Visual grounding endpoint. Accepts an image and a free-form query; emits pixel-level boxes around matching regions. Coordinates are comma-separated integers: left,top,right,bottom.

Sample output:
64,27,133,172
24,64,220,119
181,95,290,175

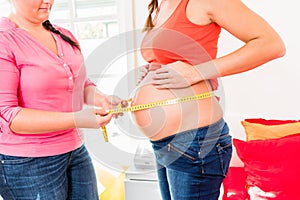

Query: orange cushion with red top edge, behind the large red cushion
241,119,300,141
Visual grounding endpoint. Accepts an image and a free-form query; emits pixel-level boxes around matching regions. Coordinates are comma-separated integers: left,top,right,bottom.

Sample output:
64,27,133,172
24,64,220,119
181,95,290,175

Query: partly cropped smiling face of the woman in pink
11,0,54,23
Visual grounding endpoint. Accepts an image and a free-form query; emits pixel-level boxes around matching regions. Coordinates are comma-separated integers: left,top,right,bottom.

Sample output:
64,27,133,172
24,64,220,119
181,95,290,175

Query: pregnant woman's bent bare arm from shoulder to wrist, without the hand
198,0,285,76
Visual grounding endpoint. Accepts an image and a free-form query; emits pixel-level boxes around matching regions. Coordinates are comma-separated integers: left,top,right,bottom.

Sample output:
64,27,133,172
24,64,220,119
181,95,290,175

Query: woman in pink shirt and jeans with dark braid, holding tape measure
0,0,121,200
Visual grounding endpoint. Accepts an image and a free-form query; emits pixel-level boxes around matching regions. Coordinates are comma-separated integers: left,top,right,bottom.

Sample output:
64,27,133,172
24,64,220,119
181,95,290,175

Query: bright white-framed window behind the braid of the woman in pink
50,0,119,56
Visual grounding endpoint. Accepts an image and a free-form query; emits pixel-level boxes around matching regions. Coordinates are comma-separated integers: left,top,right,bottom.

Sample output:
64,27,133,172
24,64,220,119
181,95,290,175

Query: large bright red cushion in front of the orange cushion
233,134,300,200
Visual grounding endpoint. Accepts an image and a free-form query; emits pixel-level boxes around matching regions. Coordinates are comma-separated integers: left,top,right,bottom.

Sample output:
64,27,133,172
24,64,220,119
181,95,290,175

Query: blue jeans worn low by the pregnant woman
151,119,232,200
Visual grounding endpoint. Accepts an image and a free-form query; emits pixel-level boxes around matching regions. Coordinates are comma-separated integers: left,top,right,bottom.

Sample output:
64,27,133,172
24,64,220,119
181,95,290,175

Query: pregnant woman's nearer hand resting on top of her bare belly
153,61,202,89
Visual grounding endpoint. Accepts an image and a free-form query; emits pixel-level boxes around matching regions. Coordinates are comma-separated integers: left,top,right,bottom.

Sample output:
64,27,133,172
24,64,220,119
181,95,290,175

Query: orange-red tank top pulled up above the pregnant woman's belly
141,0,221,89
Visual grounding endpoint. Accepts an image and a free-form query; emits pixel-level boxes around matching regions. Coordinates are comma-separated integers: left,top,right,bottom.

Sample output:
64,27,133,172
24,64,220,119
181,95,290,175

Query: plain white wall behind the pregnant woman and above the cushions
135,0,300,134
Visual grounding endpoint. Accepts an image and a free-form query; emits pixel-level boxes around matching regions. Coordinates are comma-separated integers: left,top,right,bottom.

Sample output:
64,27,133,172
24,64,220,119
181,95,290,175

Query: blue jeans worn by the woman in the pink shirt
0,146,98,200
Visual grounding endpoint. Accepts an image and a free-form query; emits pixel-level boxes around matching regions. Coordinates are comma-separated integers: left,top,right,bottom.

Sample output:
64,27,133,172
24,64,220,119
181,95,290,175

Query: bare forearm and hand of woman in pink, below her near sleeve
10,108,112,134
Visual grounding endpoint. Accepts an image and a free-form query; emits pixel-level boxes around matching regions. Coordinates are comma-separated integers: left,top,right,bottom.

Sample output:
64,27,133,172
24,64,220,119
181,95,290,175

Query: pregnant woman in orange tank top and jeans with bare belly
133,0,285,200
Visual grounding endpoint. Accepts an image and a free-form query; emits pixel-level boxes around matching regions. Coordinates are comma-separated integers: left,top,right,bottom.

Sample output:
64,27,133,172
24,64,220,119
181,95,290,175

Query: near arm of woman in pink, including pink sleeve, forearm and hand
0,69,112,134
